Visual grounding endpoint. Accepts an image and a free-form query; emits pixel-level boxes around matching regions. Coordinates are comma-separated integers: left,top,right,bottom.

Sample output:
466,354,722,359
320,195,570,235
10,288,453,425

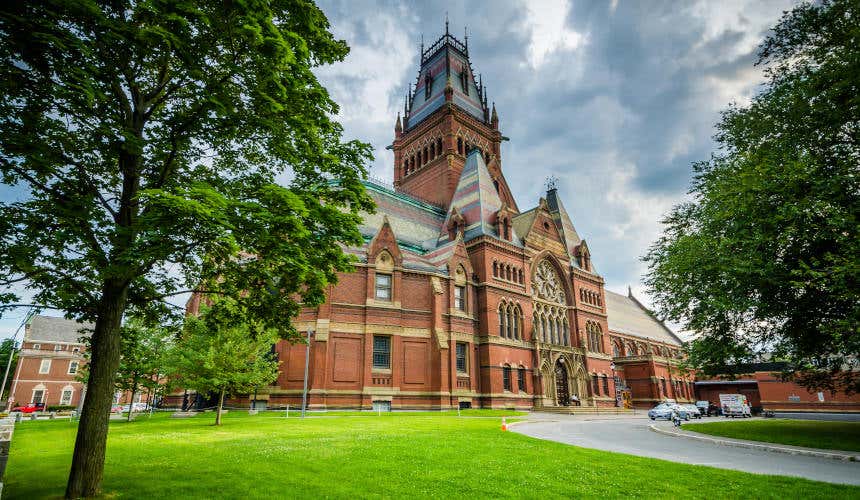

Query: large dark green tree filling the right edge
644,0,860,392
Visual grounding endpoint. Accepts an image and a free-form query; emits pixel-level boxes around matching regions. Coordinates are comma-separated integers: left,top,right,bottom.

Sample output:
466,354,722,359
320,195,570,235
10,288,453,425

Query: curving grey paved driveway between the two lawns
511,413,860,485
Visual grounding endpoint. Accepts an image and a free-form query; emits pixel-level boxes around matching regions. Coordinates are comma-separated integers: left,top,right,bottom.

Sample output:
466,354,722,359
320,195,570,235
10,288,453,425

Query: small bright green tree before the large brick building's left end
168,299,279,425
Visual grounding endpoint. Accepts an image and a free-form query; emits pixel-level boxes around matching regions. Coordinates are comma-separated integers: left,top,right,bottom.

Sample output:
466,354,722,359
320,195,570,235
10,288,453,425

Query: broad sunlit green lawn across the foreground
3,411,860,500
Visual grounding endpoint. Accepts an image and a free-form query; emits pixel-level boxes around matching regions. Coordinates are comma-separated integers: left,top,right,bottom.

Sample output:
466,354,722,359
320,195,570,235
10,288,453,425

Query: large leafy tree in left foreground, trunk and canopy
0,0,372,498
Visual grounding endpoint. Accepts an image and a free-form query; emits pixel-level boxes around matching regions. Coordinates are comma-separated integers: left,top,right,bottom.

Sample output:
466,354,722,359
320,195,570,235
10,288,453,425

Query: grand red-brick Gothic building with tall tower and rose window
189,30,693,408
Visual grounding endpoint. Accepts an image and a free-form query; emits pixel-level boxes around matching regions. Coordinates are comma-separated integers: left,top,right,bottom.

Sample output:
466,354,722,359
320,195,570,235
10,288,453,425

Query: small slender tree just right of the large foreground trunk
116,318,170,420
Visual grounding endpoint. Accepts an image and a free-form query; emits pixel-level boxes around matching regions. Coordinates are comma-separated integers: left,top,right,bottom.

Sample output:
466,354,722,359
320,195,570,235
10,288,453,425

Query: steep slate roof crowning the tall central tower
403,27,489,130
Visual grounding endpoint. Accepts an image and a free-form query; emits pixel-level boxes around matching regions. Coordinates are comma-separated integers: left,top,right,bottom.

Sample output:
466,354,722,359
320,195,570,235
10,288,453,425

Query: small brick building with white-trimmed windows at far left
7,315,92,407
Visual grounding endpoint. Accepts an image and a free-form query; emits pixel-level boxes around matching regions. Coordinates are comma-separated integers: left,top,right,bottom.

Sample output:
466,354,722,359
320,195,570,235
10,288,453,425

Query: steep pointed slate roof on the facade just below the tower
438,149,519,245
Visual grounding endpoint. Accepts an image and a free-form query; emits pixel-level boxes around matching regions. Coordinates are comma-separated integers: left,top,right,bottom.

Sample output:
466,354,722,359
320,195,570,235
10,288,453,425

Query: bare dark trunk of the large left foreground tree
66,282,128,498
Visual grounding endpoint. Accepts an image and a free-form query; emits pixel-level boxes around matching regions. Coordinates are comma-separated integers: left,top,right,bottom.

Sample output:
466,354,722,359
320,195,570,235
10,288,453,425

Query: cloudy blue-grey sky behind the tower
0,0,793,337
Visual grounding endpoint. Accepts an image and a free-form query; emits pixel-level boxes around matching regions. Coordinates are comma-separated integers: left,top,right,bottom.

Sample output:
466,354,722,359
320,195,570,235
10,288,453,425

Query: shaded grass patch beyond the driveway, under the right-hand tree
683,419,860,451
